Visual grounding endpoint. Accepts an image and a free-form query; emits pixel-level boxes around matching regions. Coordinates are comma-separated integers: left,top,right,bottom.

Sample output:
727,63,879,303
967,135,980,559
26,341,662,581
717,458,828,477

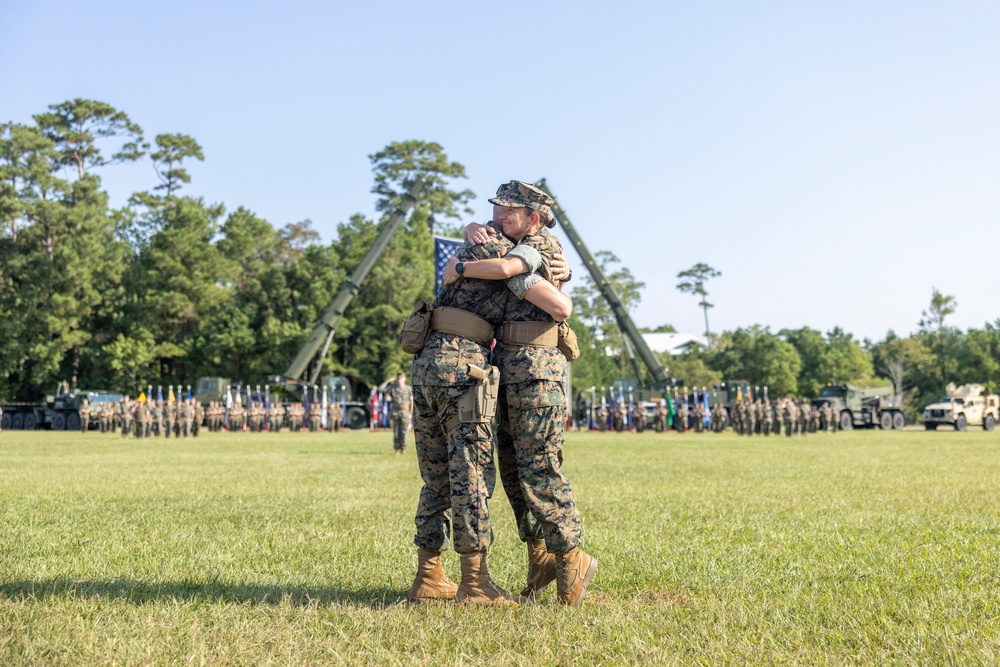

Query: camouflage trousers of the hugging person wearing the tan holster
412,385,496,553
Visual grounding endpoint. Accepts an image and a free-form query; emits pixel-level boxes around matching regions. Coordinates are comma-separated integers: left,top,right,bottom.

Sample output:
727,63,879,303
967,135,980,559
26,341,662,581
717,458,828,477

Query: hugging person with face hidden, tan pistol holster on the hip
412,206,572,604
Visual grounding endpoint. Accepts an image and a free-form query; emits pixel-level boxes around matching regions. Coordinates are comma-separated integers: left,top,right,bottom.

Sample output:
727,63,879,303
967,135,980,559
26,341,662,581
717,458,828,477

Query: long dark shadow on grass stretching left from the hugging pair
0,578,409,609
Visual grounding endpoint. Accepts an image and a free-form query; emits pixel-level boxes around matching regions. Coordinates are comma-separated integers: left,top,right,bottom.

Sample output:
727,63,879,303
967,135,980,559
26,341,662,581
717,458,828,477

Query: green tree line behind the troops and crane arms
0,99,1000,418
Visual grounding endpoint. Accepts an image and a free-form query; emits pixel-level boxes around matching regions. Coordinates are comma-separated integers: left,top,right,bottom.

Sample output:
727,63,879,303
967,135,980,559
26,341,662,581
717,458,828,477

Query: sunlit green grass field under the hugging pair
0,431,1000,665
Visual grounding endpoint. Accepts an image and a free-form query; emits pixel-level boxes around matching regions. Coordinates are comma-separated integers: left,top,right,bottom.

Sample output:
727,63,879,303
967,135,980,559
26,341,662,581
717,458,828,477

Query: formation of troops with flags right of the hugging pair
577,397,840,436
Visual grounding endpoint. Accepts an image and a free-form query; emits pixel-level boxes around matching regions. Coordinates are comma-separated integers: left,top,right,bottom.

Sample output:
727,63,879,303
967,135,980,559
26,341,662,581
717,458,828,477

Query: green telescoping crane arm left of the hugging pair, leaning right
283,178,427,386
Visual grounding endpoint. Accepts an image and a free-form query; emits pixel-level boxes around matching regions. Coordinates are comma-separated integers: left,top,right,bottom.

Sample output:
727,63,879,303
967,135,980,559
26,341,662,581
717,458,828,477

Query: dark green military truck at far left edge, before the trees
0,383,122,431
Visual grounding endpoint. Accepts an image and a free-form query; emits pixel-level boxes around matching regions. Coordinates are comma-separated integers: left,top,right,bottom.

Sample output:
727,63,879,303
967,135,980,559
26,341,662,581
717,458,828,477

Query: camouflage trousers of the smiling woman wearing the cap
497,380,583,553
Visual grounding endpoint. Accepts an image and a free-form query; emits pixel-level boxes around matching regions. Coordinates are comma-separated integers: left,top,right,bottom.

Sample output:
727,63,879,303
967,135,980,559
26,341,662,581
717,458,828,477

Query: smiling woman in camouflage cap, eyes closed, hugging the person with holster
445,181,597,606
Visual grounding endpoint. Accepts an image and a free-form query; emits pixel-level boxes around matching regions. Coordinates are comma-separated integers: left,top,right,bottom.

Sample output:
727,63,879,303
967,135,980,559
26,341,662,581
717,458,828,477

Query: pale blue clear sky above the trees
0,0,1000,340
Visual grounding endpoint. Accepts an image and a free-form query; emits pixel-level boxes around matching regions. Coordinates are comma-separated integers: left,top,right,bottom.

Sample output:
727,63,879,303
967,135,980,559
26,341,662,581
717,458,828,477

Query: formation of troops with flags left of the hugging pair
79,396,344,438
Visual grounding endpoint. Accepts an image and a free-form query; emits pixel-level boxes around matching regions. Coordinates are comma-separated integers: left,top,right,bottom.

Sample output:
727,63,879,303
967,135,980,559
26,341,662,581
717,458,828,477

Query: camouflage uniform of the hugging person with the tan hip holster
410,235,532,553
